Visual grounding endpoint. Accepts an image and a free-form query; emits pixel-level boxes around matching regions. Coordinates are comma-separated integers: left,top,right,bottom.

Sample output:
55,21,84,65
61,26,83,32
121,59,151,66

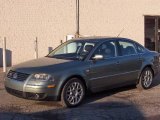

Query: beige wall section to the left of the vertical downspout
0,0,75,64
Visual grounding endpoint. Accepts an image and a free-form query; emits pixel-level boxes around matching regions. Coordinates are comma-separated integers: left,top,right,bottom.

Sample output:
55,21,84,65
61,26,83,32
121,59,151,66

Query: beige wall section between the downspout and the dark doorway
80,0,160,44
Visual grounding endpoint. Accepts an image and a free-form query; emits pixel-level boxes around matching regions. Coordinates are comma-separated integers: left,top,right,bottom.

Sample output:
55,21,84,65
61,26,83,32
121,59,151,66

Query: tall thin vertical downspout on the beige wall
75,0,79,38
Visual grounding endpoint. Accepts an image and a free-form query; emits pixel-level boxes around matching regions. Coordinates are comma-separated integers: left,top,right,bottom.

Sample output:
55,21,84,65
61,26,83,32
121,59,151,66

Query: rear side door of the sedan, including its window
117,40,142,84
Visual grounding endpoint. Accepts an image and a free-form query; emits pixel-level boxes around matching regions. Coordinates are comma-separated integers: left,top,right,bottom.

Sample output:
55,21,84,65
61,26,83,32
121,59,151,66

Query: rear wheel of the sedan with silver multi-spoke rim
137,67,153,90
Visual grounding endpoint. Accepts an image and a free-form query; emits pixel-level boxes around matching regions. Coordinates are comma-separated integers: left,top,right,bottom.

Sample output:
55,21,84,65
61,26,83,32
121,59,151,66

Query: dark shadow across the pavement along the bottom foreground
0,101,145,120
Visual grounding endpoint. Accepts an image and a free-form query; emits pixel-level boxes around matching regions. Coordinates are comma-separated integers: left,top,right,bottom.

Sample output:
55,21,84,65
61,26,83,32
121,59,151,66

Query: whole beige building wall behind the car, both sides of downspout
0,0,160,64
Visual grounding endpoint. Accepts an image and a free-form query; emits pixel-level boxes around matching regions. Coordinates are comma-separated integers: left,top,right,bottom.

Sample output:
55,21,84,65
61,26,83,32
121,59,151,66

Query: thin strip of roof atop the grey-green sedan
72,36,130,42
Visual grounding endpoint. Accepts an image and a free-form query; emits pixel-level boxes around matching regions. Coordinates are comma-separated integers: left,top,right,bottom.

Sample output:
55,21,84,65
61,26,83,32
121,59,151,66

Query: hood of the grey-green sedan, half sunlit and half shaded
11,57,78,74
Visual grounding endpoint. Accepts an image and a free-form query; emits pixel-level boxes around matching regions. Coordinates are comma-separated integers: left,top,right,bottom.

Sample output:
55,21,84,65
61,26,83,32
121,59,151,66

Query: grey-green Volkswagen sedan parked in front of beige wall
5,37,159,107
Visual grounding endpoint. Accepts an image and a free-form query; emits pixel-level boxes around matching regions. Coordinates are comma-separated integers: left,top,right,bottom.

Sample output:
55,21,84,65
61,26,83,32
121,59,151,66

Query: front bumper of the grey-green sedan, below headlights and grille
5,77,58,100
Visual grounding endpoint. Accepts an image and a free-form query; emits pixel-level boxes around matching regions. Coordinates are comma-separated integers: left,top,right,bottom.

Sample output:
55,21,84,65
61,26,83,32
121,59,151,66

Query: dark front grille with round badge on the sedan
7,70,29,81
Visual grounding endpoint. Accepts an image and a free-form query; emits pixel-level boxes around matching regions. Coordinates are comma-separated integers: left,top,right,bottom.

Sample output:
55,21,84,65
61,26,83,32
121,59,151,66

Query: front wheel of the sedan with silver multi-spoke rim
61,78,85,107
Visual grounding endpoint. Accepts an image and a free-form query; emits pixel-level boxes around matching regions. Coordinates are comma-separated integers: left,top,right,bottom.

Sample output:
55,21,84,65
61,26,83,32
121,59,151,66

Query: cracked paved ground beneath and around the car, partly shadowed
0,72,160,120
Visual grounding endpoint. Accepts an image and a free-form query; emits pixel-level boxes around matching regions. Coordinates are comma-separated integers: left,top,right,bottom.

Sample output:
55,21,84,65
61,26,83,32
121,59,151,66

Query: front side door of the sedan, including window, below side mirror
89,41,118,91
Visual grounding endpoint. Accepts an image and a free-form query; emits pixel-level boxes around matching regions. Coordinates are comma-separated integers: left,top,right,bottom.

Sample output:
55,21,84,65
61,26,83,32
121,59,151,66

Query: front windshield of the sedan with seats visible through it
46,41,96,60
